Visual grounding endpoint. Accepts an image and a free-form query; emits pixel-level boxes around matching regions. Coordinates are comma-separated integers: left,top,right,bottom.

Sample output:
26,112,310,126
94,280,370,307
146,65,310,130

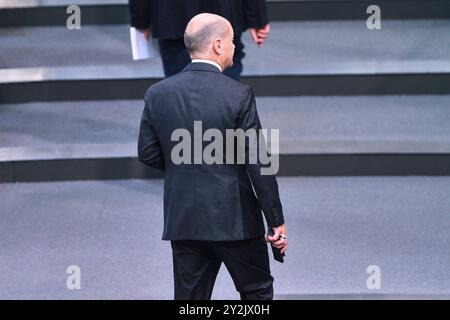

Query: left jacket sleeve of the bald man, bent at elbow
138,96,165,171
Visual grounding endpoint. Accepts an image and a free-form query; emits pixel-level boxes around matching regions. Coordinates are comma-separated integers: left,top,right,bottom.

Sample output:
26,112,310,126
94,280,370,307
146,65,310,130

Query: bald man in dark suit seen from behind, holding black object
138,13,288,299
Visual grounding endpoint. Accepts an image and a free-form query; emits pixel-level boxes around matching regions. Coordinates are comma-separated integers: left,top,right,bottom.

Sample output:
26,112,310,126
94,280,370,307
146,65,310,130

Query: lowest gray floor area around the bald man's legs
0,177,450,299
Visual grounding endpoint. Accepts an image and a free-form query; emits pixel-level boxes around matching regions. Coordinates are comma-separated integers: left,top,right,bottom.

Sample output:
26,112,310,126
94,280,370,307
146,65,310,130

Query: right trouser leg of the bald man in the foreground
214,236,273,300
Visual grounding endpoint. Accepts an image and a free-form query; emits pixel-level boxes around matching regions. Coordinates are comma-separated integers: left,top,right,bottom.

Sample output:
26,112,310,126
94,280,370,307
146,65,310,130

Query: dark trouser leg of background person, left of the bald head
158,38,191,77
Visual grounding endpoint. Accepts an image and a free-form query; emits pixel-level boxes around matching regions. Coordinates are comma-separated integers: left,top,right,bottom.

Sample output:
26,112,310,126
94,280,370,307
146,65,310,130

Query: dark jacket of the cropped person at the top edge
129,0,268,39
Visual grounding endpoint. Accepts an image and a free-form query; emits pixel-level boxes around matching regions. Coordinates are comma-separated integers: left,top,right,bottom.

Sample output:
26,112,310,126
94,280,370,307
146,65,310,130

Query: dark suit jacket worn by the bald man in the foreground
138,63,284,241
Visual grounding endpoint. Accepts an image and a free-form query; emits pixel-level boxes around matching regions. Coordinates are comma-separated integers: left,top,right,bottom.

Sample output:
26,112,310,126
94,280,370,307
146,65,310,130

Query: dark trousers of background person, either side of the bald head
158,35,245,81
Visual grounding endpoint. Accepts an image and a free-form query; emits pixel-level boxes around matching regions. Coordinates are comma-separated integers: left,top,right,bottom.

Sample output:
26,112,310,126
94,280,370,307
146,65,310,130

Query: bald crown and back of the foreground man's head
184,13,233,56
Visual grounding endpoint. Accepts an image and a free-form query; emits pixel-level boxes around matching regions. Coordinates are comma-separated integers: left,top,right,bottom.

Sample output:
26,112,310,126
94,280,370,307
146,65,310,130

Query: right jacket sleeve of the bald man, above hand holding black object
237,86,284,227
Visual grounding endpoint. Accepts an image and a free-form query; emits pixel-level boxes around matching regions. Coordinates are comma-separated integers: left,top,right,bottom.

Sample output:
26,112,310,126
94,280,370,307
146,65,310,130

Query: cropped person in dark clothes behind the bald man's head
129,0,270,80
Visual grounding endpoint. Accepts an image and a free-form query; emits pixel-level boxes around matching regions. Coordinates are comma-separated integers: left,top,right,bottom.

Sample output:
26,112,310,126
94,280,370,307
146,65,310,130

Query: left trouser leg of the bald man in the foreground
171,241,222,300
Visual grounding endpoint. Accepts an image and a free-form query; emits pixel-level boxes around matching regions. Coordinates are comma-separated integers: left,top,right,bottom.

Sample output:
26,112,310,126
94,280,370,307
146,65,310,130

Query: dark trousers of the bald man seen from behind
171,237,273,300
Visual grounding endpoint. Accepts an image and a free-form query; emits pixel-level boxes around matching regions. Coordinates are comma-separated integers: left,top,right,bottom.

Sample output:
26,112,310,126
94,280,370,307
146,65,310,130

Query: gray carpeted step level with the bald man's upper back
0,95,450,151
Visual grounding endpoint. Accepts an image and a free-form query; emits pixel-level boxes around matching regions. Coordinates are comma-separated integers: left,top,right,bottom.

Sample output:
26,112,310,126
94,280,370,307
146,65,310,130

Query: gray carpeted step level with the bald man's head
0,19,450,73
